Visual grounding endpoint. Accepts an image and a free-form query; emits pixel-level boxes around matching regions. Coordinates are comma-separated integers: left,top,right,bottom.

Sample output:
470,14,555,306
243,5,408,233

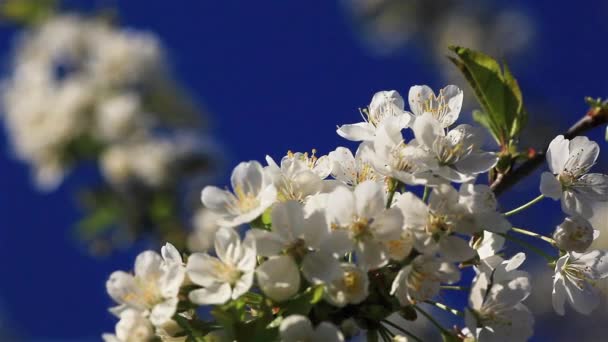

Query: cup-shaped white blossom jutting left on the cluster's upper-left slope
201,161,277,227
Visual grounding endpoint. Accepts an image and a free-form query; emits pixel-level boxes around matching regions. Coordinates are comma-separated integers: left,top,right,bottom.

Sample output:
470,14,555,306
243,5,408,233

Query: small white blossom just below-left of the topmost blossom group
328,147,380,186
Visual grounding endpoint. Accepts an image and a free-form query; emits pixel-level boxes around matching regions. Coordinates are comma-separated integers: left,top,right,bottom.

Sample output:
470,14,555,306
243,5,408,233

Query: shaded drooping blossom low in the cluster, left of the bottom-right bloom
391,255,460,306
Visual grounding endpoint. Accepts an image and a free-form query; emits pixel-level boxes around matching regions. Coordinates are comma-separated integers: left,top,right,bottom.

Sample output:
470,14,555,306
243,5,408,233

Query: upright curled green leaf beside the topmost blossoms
449,46,527,147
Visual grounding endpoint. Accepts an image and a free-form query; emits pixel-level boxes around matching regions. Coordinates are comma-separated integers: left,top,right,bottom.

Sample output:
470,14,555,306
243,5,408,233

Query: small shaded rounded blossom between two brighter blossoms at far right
553,216,599,253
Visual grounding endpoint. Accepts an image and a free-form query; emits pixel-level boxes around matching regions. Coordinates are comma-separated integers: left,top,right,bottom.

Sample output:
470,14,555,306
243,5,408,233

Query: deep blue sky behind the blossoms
0,0,608,341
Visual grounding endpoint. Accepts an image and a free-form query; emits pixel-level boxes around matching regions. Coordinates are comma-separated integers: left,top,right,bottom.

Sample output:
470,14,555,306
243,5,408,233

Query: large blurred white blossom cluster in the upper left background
1,15,204,189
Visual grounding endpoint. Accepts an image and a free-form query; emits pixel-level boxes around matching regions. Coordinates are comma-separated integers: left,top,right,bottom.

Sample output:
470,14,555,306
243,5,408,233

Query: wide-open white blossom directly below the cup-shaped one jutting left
186,228,256,305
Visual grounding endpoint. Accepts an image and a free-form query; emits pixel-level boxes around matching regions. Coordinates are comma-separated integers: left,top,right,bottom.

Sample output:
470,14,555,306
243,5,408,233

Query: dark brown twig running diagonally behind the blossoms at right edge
492,108,608,196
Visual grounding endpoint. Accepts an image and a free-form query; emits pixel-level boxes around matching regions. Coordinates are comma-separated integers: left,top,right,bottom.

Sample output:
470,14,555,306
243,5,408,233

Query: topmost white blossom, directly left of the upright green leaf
408,85,464,128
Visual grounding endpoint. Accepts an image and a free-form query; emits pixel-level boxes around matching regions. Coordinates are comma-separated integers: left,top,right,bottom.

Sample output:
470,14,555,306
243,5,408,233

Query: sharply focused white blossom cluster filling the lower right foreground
105,85,608,341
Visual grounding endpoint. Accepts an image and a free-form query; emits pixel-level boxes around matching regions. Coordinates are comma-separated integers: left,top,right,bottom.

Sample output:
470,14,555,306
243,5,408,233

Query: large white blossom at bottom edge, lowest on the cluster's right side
465,253,534,342
